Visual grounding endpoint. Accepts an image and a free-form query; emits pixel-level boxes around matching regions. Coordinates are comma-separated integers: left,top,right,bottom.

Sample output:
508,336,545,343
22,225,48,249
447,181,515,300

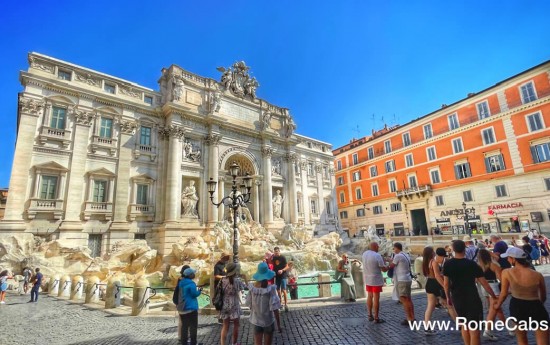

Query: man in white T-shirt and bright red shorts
363,242,388,323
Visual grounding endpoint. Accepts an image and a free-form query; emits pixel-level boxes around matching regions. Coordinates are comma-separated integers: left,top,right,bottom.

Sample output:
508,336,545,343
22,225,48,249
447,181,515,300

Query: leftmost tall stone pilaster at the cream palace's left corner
0,96,44,224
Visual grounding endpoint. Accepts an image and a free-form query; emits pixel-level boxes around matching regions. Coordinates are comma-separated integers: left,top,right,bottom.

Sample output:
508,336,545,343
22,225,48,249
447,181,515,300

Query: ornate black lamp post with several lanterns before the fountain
206,162,252,263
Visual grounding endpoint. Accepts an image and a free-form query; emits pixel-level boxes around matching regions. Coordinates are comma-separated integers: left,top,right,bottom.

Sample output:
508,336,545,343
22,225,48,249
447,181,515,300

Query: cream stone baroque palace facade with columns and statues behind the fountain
0,53,337,255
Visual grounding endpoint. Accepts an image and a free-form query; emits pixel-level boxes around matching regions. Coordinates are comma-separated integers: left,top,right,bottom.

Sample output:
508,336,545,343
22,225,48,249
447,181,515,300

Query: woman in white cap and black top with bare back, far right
494,247,550,345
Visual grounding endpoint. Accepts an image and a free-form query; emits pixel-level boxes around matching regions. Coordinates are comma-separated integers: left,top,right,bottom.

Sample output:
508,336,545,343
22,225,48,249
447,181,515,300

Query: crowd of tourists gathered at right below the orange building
362,232,550,345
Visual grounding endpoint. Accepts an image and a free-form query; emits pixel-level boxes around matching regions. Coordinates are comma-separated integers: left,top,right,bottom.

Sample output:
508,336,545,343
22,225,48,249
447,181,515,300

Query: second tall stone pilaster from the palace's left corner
59,109,96,245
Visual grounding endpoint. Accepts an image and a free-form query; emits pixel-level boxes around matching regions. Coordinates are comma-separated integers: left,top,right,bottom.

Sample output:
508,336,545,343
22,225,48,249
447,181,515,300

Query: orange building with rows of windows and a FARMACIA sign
333,61,550,235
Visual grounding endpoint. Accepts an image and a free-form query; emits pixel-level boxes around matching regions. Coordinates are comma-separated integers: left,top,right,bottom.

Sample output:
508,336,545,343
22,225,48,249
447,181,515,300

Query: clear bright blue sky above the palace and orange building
0,0,550,187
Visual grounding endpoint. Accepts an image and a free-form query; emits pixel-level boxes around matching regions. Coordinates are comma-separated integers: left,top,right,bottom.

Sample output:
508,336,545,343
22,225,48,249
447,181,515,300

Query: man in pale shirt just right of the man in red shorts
389,242,414,326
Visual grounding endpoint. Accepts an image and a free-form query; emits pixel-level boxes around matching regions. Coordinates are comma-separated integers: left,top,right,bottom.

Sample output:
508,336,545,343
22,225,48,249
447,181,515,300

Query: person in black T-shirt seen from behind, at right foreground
443,240,496,345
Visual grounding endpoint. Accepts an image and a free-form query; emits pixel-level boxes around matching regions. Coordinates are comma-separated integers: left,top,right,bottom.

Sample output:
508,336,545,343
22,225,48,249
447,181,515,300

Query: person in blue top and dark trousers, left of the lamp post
177,268,202,345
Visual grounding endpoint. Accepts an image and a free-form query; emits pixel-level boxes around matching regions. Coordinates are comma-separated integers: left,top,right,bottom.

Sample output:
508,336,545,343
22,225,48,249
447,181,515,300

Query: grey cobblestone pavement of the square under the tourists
0,265,550,345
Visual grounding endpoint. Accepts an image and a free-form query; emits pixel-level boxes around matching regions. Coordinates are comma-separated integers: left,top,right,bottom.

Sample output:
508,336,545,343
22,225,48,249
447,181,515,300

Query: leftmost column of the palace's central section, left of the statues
164,125,183,222
